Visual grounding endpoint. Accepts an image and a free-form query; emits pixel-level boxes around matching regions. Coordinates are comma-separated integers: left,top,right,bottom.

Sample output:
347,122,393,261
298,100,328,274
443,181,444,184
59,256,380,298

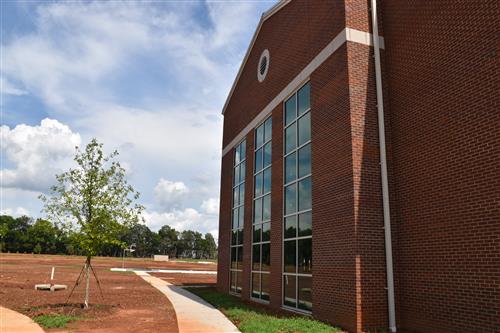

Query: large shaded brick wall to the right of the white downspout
381,0,500,333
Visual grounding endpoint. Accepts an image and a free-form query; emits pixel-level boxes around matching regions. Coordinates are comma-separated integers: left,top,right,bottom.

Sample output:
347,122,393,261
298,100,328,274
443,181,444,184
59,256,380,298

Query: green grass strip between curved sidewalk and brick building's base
186,288,342,333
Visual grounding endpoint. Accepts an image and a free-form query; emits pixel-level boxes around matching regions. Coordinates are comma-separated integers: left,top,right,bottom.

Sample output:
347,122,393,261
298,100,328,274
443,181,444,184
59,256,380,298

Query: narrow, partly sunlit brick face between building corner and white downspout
347,42,387,331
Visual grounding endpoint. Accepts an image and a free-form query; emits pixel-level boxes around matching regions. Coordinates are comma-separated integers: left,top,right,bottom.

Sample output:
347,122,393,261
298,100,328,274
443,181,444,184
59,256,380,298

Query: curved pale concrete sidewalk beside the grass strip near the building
135,272,240,333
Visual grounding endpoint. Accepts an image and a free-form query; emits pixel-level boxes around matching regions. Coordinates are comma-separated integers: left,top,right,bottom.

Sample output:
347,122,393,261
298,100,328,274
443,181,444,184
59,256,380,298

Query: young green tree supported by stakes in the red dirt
40,139,144,307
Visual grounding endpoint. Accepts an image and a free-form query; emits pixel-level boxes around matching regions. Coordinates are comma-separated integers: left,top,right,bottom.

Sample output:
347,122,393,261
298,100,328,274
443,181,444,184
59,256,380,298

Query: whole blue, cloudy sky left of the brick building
0,0,275,238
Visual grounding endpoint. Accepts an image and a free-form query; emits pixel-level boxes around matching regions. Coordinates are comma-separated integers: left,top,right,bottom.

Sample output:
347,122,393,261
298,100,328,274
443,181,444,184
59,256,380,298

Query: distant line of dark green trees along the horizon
0,215,217,259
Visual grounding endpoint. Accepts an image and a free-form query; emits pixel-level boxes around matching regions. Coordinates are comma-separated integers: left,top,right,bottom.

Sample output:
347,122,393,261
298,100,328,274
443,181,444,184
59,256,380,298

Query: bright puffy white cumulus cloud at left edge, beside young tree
0,119,81,192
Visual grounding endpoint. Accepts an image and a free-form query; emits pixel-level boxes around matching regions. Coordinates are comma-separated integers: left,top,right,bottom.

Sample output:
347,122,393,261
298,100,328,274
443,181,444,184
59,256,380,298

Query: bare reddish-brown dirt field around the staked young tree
0,254,217,333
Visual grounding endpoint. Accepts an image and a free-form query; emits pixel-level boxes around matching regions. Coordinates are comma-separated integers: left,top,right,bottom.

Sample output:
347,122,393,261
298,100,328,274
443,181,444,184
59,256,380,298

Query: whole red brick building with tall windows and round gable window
218,0,500,332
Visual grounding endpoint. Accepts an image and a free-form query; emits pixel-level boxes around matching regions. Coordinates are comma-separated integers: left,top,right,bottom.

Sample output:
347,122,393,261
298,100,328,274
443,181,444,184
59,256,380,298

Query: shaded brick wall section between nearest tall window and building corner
311,45,356,330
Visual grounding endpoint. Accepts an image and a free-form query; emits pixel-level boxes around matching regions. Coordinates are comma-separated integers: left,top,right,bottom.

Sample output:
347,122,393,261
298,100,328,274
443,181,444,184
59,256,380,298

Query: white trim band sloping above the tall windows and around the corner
222,28,384,156
